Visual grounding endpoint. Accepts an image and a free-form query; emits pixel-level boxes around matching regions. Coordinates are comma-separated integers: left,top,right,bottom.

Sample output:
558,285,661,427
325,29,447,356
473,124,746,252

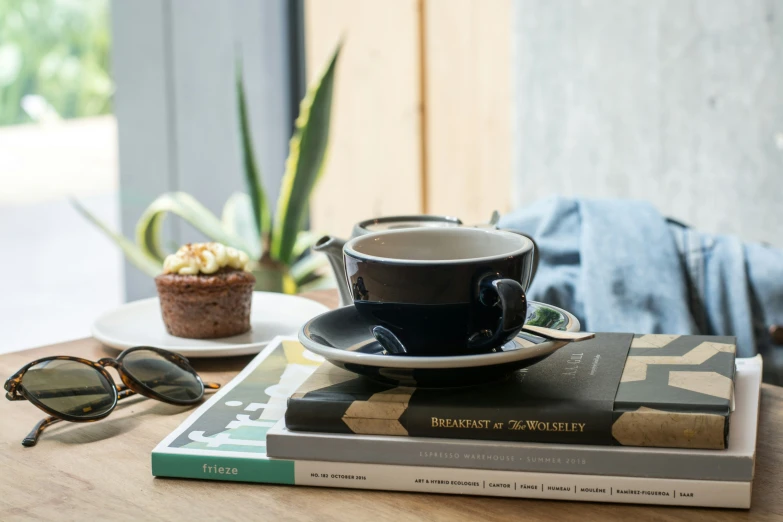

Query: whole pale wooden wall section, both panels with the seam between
305,0,511,236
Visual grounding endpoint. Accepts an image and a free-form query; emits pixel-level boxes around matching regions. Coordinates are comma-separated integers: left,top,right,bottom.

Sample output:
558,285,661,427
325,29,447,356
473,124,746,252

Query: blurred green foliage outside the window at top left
0,0,114,125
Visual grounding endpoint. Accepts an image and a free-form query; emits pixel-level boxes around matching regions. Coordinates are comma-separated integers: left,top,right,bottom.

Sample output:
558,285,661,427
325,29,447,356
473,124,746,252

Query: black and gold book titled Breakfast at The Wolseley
285,333,736,449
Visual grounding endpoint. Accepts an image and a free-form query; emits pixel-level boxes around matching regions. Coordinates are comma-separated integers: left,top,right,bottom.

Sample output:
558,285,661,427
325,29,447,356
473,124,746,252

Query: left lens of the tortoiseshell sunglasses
22,359,117,419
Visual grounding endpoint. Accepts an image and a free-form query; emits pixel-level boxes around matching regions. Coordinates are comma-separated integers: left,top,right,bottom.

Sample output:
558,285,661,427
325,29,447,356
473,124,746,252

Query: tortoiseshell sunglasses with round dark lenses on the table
5,346,220,446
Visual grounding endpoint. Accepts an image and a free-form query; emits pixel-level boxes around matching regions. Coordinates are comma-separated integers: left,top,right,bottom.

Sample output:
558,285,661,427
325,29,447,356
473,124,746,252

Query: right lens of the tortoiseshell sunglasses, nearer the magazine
122,350,204,401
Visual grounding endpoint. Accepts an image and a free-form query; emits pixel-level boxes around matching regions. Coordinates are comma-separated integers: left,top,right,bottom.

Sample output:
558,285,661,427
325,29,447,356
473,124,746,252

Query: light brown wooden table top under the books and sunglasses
0,291,783,522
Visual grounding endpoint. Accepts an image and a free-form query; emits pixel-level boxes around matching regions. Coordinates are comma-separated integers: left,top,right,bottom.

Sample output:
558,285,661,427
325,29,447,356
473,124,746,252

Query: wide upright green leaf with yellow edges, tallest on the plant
270,44,342,264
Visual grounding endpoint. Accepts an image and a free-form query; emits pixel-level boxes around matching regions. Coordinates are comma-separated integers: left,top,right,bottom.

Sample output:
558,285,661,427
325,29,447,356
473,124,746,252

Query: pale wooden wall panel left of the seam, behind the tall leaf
305,0,422,236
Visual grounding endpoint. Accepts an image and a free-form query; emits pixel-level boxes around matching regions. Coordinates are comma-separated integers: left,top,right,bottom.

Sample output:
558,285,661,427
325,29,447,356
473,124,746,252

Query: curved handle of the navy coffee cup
471,274,527,350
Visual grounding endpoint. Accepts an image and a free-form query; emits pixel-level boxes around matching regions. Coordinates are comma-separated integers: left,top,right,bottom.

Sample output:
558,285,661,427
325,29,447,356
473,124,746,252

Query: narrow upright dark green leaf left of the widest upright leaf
236,60,272,247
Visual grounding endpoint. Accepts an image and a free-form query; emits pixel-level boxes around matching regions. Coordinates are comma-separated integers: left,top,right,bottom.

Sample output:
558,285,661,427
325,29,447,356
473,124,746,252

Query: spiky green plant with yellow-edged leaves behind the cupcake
72,45,340,293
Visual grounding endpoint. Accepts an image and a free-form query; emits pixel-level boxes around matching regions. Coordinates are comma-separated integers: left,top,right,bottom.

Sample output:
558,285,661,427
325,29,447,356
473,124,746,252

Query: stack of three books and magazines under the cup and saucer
152,334,761,508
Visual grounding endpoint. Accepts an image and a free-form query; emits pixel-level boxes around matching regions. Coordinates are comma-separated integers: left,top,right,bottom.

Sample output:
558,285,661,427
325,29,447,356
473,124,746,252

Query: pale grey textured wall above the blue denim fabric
513,0,783,246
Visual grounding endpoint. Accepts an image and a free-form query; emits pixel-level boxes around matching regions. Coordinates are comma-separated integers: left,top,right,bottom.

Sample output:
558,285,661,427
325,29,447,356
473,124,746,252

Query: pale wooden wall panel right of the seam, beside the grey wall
424,0,512,223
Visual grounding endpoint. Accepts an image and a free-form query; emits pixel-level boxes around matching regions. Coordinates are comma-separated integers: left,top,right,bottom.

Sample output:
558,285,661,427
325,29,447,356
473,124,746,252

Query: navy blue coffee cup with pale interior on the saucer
343,227,534,356
